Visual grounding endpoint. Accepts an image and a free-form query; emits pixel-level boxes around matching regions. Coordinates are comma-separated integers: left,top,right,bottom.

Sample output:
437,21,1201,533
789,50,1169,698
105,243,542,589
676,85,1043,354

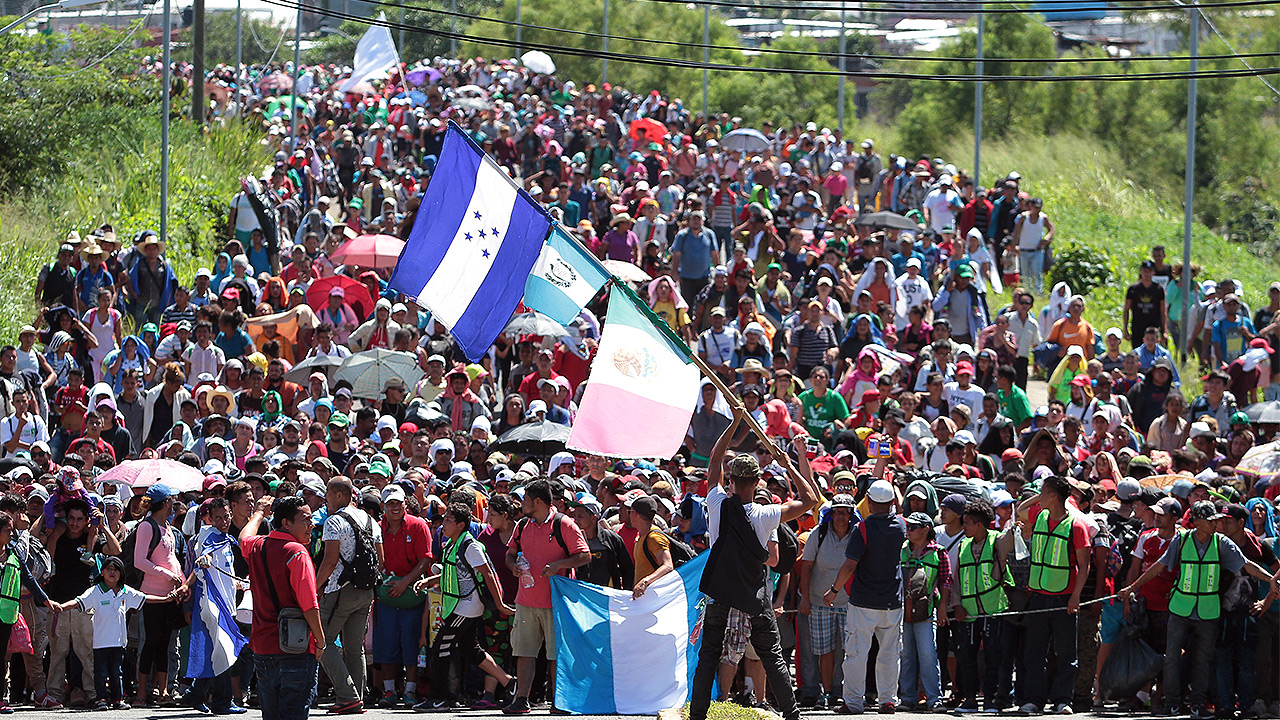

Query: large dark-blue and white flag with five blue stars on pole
390,122,552,361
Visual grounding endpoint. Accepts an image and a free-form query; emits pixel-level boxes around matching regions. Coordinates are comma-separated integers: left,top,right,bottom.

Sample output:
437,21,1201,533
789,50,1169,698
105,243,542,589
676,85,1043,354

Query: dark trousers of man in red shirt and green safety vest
1019,592,1080,707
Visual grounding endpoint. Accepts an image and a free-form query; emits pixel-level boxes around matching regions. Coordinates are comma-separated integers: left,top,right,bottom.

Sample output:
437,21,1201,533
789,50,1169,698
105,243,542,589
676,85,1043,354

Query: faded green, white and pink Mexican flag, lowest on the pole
568,284,700,457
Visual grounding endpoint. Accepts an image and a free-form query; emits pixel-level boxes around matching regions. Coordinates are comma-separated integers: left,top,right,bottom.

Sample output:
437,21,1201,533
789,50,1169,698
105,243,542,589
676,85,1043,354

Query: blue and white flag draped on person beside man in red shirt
187,525,248,678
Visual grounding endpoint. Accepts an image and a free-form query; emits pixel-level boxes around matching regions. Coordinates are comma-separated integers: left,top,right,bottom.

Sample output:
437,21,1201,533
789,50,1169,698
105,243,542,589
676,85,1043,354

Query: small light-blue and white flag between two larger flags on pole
525,223,609,325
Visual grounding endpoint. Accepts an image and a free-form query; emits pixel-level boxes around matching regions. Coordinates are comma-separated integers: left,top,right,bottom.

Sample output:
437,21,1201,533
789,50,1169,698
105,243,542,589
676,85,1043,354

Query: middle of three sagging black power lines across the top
353,0,1280,64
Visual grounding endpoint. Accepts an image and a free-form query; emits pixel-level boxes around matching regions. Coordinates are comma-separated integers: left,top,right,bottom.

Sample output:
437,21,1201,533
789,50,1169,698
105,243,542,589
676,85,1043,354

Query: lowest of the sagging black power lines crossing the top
277,0,1280,82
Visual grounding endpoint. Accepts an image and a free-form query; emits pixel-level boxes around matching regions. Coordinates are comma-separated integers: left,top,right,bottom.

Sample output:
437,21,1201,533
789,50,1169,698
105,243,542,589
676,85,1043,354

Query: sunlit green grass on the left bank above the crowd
0,118,271,342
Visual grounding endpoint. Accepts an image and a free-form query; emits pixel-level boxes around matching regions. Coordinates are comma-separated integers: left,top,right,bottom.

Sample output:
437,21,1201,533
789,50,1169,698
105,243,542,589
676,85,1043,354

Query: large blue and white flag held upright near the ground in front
552,552,708,715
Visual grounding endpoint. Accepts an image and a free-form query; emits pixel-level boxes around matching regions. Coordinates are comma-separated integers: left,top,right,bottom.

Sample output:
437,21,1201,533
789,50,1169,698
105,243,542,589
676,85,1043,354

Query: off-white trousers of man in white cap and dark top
844,605,902,710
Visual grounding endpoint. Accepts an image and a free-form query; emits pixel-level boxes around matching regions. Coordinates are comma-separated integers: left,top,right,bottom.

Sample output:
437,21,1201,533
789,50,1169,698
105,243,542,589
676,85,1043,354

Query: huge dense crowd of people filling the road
0,53,1280,720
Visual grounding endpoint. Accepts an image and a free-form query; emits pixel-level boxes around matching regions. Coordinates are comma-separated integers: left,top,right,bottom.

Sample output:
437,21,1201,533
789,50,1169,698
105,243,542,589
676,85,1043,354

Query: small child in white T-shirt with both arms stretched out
49,555,178,710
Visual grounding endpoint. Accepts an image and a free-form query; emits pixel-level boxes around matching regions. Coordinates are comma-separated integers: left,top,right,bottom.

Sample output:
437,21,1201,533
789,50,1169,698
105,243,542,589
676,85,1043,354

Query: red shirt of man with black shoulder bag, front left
241,530,319,655
